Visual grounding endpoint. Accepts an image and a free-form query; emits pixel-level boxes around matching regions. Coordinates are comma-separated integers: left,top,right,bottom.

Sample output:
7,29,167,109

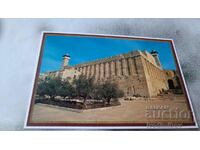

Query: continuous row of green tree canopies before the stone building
37,75,124,105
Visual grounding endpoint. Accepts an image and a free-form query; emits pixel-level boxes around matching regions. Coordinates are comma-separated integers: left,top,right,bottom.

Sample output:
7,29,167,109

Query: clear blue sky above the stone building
40,35,175,73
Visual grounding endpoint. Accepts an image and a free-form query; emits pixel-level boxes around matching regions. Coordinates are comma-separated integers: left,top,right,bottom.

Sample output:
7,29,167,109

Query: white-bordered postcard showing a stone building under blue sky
25,32,197,129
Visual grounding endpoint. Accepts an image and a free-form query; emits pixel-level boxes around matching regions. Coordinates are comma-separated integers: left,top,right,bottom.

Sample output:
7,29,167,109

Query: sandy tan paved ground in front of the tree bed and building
31,95,192,123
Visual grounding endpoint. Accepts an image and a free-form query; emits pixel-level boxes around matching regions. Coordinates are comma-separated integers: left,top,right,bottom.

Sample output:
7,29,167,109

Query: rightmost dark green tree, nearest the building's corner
96,81,124,104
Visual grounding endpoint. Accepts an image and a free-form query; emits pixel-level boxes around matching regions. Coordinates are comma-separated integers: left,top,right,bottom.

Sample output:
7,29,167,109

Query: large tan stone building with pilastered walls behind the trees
42,50,177,97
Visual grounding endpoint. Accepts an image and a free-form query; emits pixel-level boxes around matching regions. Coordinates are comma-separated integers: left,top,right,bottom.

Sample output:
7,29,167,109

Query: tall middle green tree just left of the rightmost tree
73,75,94,106
